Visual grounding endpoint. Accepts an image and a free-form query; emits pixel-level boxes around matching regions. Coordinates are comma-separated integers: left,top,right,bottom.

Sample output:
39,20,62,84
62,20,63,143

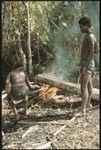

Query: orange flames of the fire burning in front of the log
39,84,58,101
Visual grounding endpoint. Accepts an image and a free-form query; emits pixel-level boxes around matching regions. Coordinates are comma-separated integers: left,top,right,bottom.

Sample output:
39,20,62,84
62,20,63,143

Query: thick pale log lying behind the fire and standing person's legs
36,74,99,101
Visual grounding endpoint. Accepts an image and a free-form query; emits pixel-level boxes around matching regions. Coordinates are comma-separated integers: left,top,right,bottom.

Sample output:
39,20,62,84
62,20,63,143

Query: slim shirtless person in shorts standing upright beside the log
75,16,96,116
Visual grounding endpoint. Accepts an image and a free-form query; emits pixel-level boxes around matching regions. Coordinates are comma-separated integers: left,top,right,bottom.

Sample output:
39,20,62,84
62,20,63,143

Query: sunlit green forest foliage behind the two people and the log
2,1,99,89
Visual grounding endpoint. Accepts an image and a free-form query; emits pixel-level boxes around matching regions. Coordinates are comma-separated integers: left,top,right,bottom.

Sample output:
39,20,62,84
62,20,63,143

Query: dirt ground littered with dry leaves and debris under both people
2,89,100,149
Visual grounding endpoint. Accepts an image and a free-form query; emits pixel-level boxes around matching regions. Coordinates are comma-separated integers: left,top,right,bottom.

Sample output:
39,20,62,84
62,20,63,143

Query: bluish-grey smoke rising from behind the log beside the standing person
44,1,99,82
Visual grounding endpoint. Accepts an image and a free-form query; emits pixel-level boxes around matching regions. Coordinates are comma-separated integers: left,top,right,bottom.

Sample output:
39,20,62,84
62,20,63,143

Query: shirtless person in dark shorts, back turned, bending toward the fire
5,63,35,117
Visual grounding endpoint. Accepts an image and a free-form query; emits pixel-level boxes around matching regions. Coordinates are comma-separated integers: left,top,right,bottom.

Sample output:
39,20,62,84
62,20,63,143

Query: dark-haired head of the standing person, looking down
78,16,91,33
